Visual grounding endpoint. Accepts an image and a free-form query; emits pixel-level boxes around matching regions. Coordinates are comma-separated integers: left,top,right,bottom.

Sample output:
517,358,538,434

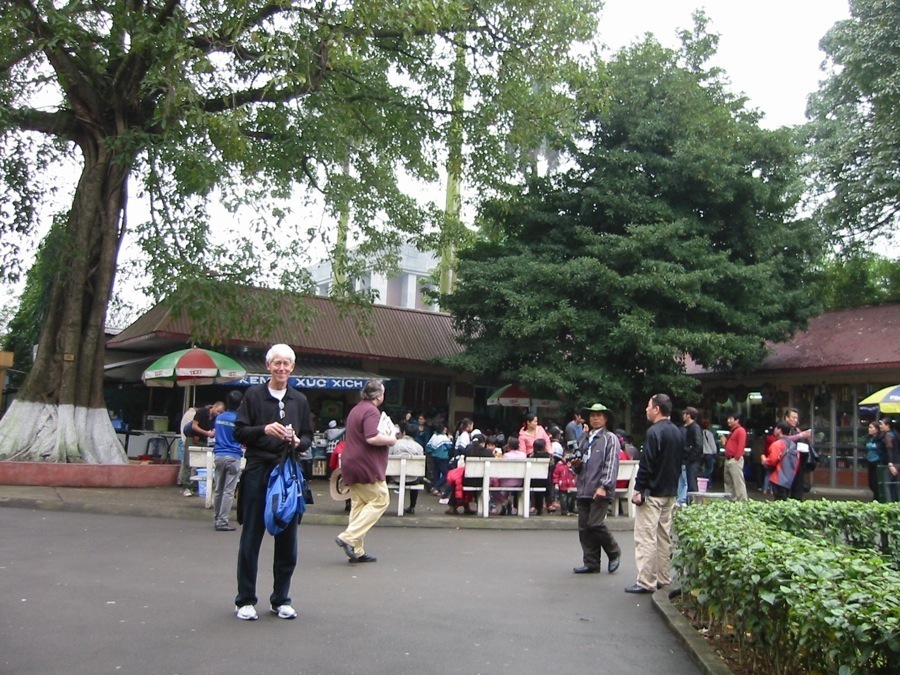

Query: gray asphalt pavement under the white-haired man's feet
0,510,701,674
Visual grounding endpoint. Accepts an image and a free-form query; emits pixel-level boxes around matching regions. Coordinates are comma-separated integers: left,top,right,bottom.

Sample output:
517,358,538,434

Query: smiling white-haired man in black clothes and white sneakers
234,344,313,621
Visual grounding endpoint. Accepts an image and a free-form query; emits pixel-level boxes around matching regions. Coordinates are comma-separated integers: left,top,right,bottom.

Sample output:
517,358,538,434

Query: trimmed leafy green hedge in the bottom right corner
674,501,900,673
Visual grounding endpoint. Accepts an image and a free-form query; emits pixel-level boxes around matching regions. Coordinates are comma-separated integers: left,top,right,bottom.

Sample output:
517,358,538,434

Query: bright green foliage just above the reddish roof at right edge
821,247,900,310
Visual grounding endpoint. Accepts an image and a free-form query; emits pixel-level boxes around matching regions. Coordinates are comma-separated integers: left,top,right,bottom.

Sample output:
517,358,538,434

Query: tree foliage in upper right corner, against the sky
807,0,900,246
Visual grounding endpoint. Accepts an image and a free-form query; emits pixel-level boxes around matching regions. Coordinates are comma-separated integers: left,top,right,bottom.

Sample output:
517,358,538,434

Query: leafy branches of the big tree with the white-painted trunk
0,0,600,336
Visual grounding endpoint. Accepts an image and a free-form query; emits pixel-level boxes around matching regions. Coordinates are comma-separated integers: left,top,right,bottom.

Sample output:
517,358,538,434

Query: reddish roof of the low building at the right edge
688,304,900,375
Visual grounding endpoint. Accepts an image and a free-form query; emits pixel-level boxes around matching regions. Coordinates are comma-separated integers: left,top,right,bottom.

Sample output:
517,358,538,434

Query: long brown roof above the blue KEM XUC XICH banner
107,289,462,362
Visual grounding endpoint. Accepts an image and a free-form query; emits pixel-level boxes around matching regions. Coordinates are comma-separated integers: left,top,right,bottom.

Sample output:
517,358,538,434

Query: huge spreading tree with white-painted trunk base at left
0,0,598,462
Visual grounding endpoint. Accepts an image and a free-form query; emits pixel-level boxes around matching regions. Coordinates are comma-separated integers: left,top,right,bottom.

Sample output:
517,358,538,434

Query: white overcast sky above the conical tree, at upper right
600,0,850,128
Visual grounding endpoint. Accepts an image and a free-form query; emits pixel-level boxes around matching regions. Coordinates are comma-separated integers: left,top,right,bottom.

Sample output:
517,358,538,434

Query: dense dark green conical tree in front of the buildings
441,23,821,403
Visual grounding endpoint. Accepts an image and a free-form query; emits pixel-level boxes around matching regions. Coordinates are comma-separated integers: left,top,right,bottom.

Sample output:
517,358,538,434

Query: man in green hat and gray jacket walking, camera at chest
571,403,622,574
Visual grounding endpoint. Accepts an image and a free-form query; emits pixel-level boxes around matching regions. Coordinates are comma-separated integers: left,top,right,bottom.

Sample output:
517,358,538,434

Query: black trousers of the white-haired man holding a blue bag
234,465,299,607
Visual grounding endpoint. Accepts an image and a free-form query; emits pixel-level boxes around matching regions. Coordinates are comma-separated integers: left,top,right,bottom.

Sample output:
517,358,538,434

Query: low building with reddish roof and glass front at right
688,304,900,488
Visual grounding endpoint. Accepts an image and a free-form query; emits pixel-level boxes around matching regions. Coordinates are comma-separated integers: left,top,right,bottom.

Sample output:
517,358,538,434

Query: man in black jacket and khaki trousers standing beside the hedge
625,394,684,593
